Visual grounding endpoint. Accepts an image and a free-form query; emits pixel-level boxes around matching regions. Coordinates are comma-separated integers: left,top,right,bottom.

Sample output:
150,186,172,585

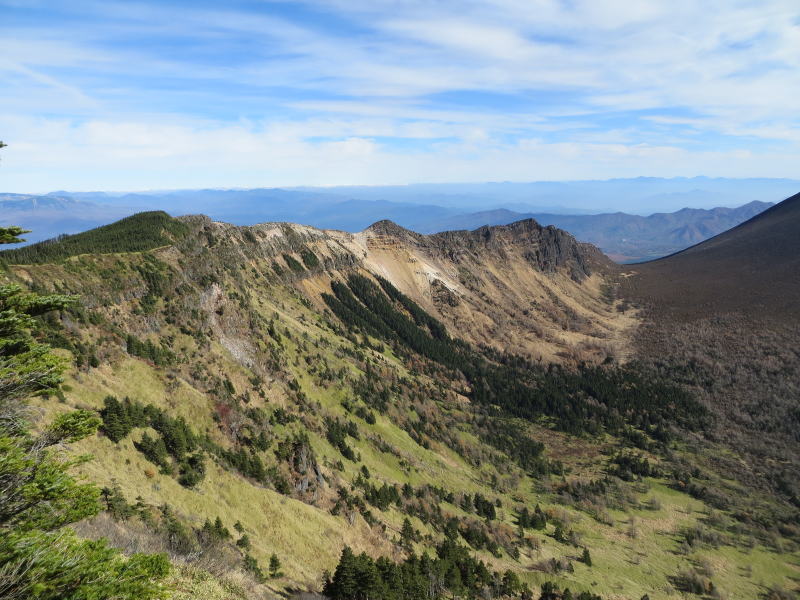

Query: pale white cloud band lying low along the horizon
0,120,800,192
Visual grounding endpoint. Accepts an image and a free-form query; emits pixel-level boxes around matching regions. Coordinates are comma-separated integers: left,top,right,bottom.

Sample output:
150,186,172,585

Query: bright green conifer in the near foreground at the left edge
0,227,170,600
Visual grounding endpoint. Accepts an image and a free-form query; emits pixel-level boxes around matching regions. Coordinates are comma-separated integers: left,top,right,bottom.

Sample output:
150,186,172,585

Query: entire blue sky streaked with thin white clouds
0,0,800,192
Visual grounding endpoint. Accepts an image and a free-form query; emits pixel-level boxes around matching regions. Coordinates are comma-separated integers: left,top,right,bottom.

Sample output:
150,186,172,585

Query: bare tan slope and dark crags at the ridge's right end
332,219,635,361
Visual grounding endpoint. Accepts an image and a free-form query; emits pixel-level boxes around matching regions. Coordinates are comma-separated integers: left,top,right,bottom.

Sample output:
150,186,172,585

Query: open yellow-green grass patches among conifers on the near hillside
20,243,798,599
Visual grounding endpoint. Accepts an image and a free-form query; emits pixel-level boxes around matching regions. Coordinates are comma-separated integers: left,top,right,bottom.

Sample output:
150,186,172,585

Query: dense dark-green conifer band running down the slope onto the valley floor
323,275,710,442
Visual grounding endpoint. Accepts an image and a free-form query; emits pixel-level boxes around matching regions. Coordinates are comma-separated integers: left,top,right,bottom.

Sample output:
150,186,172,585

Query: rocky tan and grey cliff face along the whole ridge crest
162,217,635,361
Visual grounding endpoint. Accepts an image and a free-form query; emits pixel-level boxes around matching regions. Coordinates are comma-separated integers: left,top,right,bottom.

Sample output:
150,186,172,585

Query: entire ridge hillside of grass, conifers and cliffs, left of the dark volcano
0,213,800,600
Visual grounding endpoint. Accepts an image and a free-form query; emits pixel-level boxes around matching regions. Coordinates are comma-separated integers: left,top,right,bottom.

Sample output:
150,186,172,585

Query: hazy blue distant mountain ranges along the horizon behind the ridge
0,177,788,262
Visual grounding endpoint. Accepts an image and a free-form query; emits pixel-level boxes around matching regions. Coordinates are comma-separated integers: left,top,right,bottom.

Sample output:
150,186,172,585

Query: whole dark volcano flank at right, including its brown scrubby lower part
619,194,800,520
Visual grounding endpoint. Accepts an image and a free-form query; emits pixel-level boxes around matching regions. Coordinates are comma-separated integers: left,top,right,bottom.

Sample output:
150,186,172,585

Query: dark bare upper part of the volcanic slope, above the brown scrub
622,194,800,320
